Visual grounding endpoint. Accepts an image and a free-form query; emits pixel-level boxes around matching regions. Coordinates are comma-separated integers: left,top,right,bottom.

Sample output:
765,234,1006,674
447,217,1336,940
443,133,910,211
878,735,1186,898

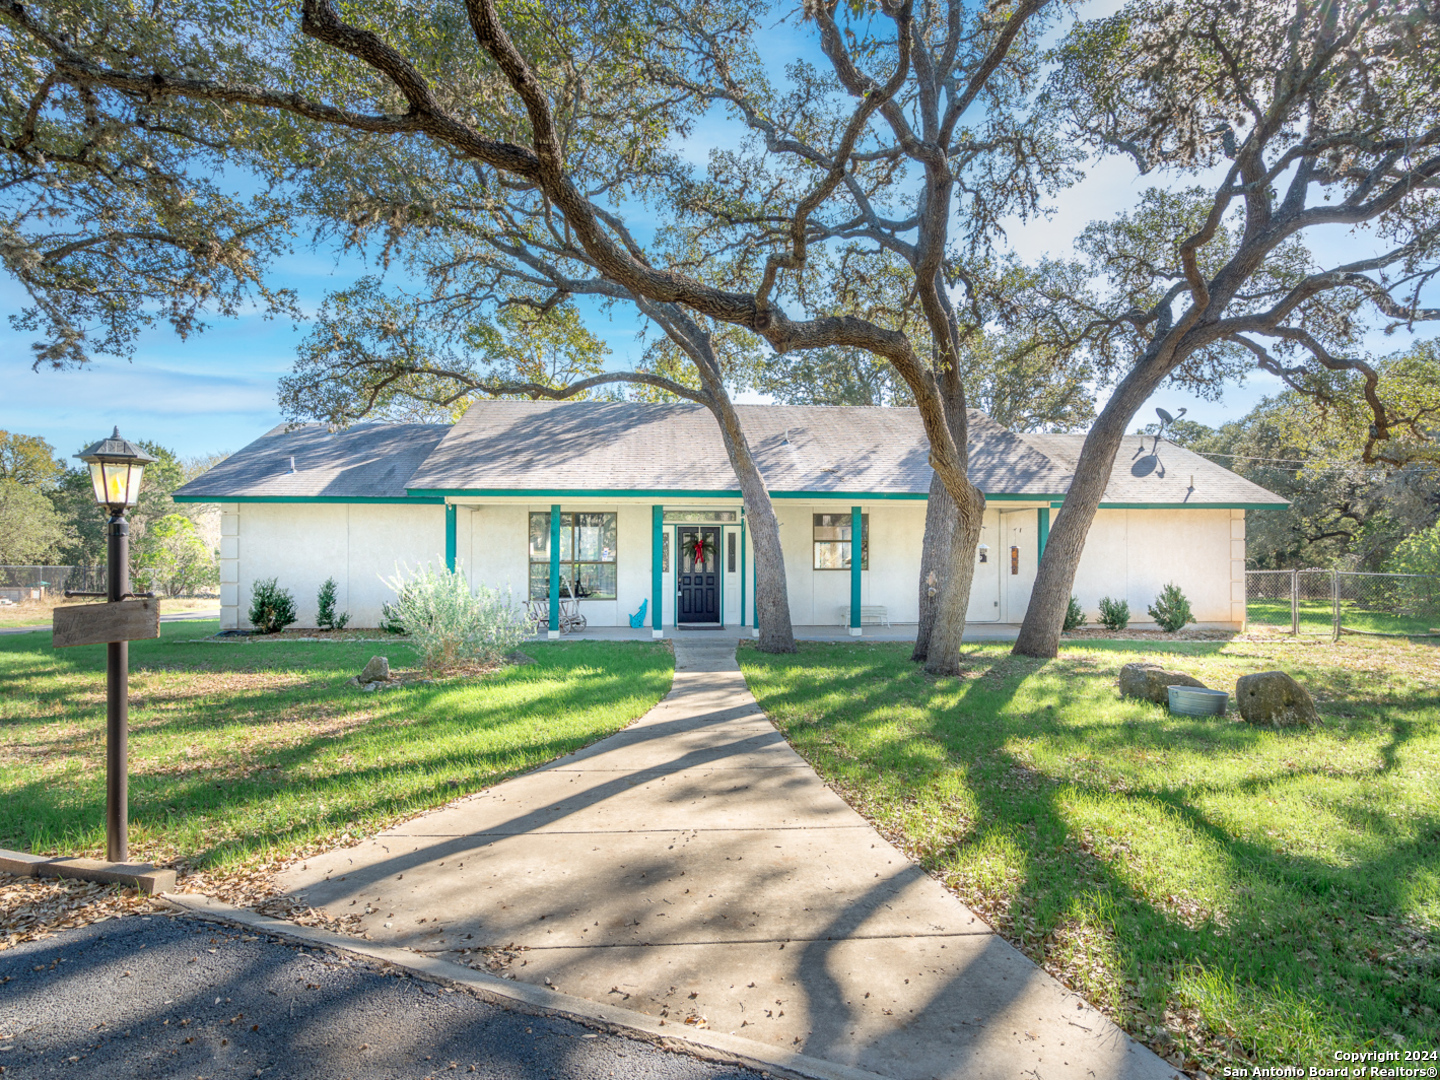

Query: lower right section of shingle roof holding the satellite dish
1021,433,1286,505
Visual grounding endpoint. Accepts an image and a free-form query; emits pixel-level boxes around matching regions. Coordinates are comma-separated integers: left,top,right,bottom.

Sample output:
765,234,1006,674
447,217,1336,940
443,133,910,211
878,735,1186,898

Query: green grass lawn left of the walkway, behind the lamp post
0,622,674,870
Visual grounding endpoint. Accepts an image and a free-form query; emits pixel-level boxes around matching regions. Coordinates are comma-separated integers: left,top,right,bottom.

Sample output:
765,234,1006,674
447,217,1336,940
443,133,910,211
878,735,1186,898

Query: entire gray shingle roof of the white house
176,400,1283,505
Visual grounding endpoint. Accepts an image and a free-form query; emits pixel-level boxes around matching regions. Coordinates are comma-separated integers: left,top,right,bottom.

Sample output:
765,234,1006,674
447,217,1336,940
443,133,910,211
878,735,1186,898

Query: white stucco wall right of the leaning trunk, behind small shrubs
1071,510,1246,626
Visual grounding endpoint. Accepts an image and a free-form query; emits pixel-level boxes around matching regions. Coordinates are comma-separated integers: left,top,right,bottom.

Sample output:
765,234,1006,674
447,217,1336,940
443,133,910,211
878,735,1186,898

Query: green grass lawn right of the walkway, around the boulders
740,639,1440,1070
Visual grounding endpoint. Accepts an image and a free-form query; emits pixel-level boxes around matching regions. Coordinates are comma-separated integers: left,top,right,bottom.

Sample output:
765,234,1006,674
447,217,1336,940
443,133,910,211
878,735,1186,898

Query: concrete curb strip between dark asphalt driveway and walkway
158,893,884,1080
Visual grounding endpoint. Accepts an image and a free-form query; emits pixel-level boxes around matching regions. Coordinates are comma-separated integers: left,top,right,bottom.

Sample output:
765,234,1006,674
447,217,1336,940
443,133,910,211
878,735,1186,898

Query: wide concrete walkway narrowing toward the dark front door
277,634,1175,1080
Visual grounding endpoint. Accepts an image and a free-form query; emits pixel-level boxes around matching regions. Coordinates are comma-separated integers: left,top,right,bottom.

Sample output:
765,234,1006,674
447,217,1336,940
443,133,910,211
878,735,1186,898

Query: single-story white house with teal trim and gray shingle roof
176,400,1284,634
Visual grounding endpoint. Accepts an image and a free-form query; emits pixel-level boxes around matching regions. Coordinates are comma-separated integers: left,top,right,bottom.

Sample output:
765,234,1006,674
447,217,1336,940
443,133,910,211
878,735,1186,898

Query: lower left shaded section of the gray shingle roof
176,423,451,503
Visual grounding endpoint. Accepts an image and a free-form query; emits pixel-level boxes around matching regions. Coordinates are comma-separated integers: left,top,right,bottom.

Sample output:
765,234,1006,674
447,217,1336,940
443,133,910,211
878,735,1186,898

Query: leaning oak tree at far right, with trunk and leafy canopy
1015,0,1440,657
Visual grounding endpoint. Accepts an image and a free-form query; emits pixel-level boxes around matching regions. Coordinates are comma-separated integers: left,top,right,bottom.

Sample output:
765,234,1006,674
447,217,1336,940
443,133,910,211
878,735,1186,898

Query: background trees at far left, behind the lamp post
0,431,226,596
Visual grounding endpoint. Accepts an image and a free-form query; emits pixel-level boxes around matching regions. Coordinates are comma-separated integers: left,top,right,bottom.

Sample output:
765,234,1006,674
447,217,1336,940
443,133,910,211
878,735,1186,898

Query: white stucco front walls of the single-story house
220,500,1246,628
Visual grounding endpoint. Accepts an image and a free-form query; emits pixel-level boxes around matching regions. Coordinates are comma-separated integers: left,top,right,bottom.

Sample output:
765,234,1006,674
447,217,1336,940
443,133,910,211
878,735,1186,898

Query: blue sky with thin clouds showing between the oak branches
0,3,1407,456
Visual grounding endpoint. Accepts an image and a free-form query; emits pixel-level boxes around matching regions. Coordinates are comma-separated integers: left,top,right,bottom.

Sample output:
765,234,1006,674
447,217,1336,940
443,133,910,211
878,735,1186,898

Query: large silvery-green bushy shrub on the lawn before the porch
386,563,534,671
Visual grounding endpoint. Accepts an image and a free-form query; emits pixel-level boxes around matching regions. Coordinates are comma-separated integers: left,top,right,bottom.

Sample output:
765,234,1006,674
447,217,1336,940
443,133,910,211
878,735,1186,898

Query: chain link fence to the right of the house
1246,570,1440,639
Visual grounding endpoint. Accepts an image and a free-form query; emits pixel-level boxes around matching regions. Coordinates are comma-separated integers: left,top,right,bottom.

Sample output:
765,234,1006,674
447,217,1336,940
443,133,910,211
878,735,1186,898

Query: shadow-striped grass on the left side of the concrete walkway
0,633,671,867
